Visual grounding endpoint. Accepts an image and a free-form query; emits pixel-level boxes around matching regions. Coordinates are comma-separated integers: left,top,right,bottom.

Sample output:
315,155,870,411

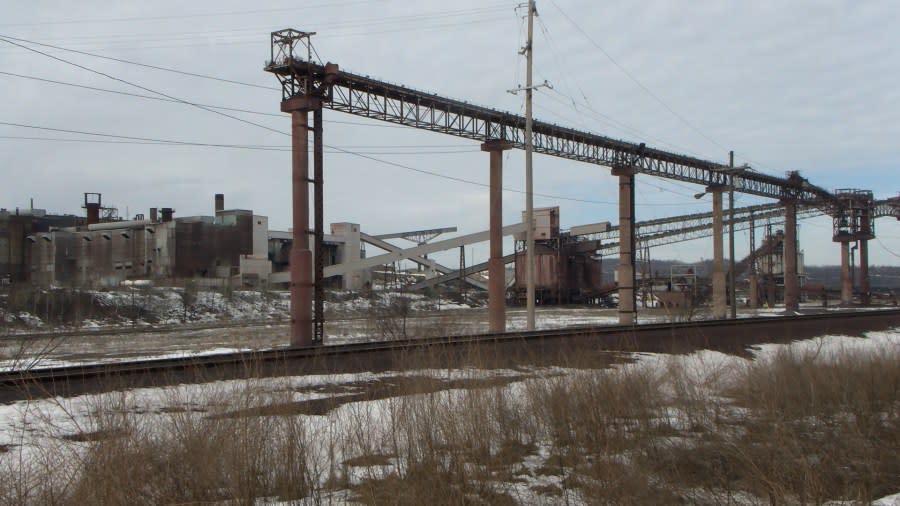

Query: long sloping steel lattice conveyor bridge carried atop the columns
266,55,833,206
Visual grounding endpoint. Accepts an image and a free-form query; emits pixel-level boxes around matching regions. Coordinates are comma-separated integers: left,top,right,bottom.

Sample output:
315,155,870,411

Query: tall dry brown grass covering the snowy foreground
0,334,900,505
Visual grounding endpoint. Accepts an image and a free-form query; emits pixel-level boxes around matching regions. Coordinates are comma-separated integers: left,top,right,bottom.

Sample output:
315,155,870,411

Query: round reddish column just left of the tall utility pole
481,140,510,332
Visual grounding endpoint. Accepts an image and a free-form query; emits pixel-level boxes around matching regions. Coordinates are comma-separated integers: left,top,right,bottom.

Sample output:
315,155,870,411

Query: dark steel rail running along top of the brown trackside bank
0,309,900,402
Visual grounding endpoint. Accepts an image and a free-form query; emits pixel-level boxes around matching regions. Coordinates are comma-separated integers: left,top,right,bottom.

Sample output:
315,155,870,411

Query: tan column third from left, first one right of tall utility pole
612,166,637,325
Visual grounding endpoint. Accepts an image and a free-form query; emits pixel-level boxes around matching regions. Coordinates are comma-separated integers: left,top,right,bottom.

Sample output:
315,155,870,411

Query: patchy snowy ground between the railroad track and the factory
0,288,888,370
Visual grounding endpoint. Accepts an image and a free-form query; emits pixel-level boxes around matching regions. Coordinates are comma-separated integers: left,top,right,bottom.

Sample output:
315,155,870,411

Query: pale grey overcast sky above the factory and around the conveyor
0,0,900,265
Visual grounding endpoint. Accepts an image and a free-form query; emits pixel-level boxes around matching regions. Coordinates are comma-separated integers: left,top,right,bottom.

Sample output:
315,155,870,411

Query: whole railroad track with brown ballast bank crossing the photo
0,309,900,402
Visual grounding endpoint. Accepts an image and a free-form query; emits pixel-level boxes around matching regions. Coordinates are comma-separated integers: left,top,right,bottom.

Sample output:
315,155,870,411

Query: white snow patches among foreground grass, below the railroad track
0,327,900,506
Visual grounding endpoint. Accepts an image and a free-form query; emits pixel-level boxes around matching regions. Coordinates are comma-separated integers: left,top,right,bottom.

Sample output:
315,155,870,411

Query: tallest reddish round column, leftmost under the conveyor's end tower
281,97,322,346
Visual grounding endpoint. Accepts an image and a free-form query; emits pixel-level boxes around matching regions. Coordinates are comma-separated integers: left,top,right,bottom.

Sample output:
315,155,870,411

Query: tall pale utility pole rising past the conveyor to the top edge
525,0,535,330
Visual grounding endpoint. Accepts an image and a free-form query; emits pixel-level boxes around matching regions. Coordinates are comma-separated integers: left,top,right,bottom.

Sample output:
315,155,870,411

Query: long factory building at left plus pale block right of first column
0,193,369,289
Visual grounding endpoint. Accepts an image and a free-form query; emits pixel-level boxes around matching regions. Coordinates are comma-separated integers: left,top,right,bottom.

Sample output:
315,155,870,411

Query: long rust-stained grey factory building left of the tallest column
22,194,271,288
